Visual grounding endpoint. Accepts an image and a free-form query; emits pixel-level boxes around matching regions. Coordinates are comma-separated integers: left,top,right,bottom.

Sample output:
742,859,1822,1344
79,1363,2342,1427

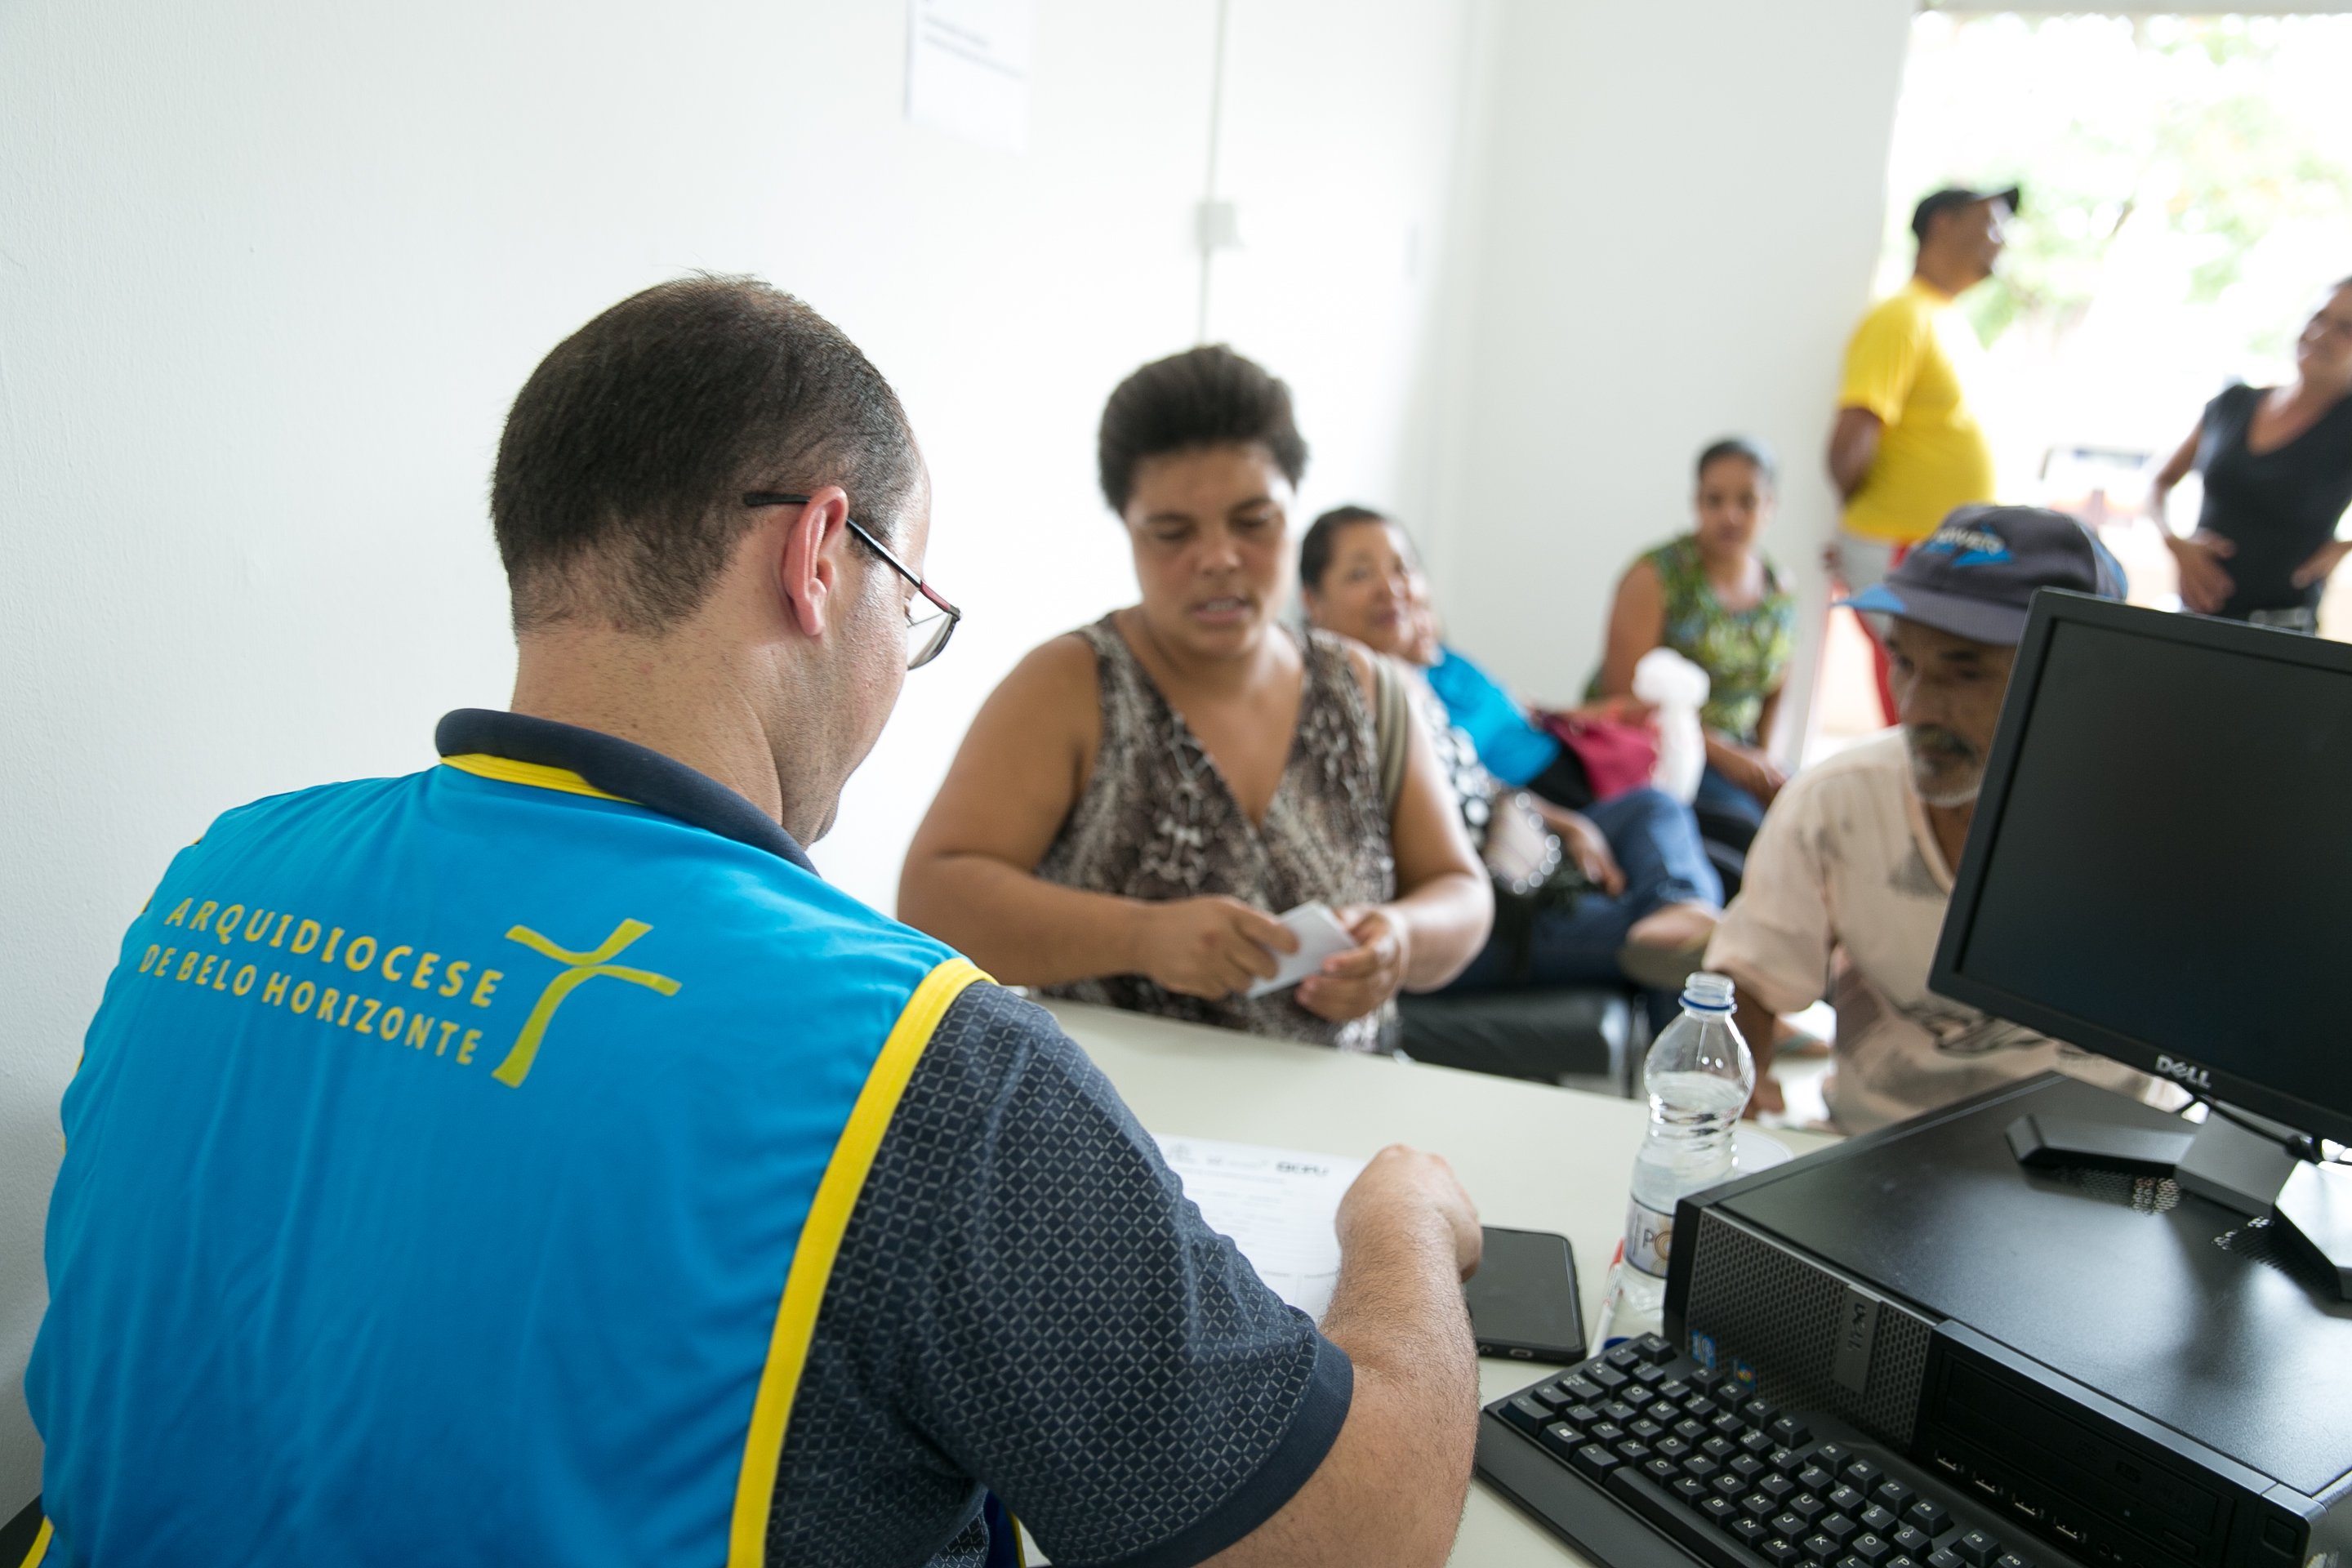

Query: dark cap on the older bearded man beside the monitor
1839,506,2124,647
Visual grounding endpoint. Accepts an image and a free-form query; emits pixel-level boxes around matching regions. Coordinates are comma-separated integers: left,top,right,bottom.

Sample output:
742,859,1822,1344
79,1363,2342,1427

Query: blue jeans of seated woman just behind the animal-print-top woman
1446,790,1724,992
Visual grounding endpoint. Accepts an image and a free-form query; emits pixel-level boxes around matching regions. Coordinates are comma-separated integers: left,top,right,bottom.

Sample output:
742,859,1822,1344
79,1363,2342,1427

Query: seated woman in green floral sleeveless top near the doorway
1592,437,1797,851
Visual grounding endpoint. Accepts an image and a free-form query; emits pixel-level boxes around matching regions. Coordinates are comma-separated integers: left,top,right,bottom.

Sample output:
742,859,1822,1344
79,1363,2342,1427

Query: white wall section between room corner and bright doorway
1428,0,1912,761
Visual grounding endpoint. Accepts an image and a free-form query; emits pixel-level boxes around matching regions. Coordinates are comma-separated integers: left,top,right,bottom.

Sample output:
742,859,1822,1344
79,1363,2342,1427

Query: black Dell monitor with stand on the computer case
1929,590,2352,1297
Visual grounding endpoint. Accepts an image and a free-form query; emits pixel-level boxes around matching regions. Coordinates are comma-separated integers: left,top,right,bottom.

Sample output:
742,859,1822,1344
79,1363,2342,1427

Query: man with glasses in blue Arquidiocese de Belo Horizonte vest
26,278,1477,1568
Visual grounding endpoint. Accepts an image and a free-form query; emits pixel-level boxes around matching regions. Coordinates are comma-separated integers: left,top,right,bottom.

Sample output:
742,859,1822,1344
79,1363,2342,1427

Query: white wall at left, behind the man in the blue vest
0,0,1475,1517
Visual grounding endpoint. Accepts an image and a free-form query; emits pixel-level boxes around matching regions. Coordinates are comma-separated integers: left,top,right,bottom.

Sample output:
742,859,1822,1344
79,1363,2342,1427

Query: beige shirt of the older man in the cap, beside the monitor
1708,728,2147,1133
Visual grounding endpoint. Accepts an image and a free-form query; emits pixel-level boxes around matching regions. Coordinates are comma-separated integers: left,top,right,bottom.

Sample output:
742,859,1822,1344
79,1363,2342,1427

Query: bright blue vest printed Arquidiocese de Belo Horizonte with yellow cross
26,726,983,1568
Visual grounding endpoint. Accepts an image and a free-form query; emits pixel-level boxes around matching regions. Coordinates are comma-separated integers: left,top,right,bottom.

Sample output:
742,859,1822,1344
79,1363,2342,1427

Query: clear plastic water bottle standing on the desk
1599,973,1757,1349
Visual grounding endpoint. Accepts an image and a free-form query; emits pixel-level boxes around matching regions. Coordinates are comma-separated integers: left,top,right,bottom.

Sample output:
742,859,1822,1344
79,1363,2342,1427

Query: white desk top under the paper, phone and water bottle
1051,1001,1828,1568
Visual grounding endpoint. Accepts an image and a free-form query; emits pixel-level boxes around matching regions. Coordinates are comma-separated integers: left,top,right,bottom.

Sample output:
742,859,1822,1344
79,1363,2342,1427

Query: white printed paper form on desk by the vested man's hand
1152,1133,1364,1321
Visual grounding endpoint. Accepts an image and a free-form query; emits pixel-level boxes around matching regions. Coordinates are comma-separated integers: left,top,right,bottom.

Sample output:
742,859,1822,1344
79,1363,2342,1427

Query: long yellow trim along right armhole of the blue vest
727,959,988,1568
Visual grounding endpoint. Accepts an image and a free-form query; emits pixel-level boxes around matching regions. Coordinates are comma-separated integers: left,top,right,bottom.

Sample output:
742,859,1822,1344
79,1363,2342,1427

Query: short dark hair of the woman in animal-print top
1096,343,1307,514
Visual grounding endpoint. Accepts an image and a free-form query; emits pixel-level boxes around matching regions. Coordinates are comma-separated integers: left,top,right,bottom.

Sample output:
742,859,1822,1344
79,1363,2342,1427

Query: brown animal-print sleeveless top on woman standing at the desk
1037,616,1397,1051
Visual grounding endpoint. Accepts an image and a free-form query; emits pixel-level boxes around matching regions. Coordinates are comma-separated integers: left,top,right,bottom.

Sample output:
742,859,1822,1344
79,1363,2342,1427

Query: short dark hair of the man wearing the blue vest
489,275,922,635
